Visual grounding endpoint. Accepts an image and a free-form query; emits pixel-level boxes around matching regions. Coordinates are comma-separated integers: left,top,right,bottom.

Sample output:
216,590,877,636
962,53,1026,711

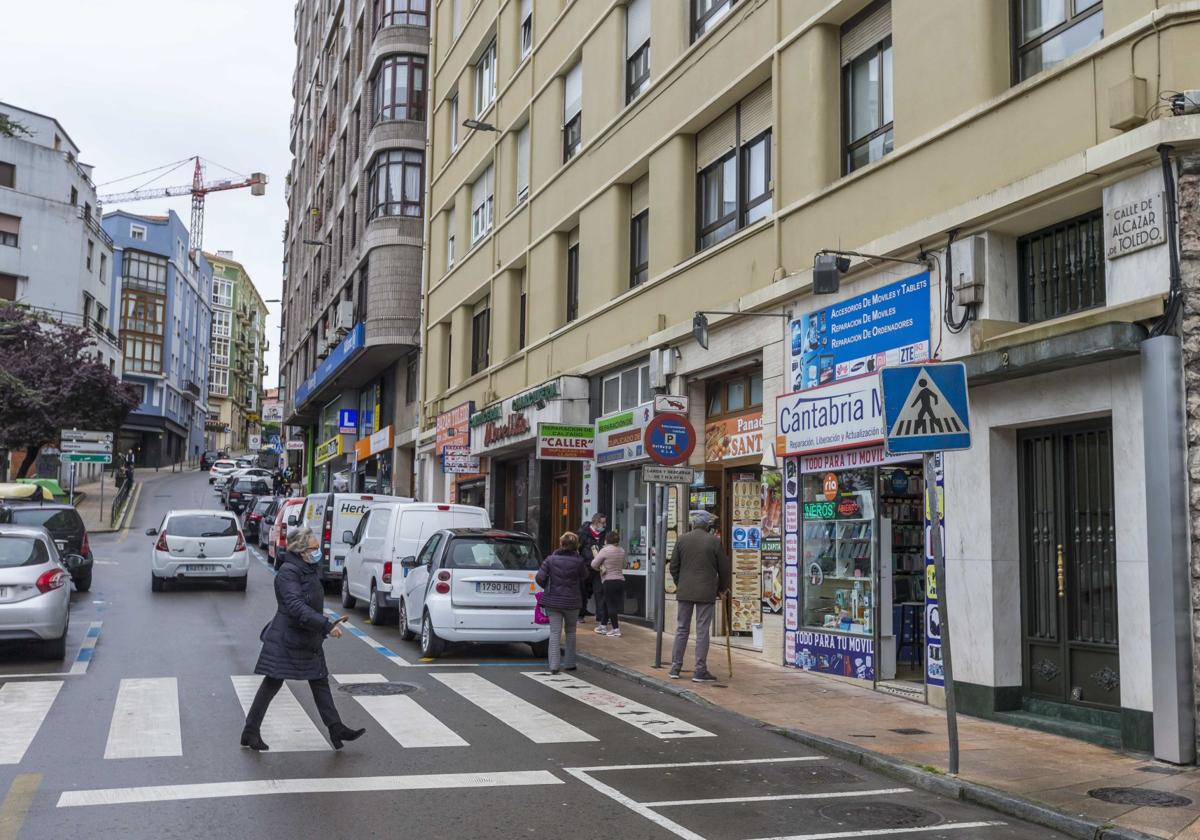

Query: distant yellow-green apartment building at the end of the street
204,251,269,452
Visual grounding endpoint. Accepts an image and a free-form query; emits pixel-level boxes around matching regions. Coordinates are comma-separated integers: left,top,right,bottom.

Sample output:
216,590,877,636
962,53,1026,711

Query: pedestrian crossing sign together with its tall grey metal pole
880,362,971,775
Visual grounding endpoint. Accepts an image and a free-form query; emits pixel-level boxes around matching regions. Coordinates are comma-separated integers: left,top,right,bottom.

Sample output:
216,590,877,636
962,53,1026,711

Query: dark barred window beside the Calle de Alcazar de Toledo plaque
1016,210,1105,323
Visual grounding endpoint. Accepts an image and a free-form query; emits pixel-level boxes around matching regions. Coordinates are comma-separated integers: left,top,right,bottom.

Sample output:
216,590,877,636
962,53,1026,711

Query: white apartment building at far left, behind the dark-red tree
0,102,121,376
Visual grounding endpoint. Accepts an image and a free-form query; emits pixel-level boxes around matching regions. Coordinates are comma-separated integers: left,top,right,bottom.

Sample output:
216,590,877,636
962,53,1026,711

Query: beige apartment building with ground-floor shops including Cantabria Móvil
419,0,1200,757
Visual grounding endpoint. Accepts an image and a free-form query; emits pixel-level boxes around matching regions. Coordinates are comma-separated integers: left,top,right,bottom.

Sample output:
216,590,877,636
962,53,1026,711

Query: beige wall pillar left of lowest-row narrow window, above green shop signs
580,184,633,313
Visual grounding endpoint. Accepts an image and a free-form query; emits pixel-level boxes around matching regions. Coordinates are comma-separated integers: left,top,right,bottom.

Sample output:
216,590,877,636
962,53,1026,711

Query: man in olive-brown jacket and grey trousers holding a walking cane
670,510,731,683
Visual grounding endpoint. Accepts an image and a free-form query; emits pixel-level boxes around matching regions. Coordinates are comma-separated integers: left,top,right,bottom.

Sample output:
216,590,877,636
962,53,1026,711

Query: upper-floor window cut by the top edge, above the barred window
1013,0,1104,82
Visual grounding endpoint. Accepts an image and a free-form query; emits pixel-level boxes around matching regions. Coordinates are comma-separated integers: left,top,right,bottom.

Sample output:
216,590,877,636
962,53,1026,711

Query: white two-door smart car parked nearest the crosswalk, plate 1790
400,528,550,658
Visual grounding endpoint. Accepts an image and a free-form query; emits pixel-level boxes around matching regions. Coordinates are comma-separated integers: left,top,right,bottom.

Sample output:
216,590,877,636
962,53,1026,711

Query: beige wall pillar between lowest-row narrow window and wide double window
652,135,696,277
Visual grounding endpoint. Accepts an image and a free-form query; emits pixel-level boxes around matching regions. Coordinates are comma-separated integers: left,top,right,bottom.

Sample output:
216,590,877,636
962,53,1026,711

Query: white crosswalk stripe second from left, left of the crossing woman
104,677,184,758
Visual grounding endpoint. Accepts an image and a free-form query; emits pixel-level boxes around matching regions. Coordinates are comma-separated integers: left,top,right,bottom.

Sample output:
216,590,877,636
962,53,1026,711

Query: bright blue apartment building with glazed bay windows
102,210,212,467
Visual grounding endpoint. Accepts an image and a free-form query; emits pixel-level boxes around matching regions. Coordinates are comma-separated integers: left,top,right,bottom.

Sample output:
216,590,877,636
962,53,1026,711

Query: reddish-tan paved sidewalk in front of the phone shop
577,623,1200,840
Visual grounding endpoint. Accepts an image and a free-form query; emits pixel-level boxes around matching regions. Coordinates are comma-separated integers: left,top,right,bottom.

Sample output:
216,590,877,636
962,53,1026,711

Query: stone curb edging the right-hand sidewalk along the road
575,650,1162,840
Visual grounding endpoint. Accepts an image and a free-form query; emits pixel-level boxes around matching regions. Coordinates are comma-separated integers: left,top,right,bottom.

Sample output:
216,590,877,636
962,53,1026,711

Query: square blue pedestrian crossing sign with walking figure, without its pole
880,361,971,455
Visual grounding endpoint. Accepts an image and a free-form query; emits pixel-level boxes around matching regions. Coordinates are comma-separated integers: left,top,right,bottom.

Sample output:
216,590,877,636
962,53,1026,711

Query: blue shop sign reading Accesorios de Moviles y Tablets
790,271,930,391
